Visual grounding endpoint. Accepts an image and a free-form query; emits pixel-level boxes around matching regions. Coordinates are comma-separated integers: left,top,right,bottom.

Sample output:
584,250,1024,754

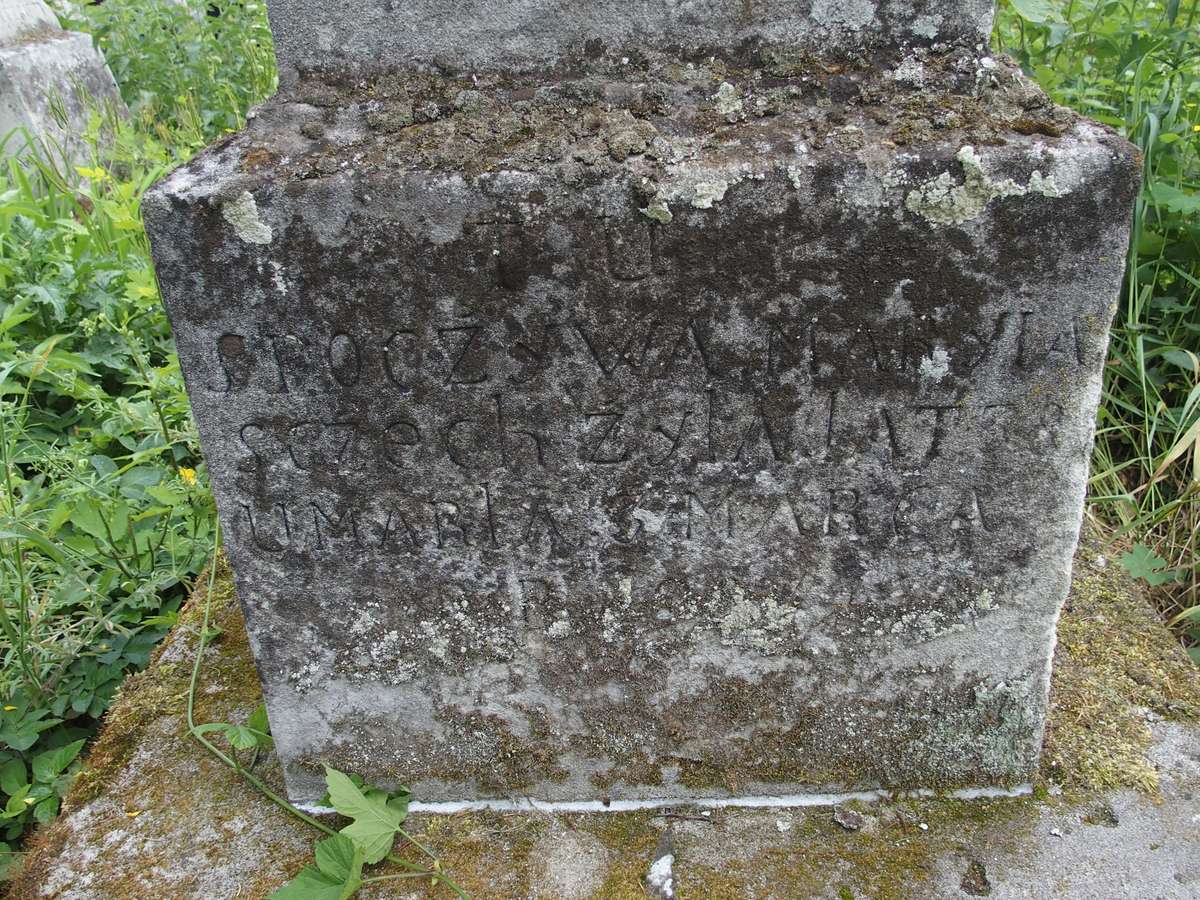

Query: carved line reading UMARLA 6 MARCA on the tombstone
236,482,1002,557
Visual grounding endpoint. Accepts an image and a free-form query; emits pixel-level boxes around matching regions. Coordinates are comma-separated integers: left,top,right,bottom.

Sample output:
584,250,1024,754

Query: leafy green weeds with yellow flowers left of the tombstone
0,0,275,874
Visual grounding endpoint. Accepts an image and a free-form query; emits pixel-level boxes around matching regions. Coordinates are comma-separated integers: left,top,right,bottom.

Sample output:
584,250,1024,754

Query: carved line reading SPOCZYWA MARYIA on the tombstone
206,310,1096,394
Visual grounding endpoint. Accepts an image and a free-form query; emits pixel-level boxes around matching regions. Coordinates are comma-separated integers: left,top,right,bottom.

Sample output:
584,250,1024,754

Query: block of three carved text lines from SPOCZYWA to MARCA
208,304,1090,571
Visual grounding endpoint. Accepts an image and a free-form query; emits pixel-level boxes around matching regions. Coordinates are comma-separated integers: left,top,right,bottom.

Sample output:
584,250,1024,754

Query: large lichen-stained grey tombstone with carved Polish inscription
145,0,1138,803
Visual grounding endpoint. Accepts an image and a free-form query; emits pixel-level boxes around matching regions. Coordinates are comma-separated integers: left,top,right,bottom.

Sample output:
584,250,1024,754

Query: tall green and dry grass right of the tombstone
995,0,1200,661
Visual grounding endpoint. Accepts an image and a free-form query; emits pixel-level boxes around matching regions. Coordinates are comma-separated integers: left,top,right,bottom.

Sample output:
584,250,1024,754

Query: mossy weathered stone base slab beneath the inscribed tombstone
12,532,1200,900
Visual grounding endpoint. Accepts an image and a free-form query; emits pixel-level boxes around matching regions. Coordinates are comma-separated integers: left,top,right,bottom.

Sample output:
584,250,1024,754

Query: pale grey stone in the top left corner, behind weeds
0,0,121,162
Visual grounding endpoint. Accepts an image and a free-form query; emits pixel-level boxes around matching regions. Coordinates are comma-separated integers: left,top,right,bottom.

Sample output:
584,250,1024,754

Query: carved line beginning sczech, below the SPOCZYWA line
239,389,1063,474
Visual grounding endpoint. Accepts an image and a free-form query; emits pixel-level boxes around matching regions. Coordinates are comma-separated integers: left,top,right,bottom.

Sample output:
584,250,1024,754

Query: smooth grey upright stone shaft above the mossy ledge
268,0,995,80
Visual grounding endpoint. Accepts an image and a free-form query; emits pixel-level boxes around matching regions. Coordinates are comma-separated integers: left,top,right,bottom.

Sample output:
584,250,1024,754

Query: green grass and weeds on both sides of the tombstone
0,0,1200,883
